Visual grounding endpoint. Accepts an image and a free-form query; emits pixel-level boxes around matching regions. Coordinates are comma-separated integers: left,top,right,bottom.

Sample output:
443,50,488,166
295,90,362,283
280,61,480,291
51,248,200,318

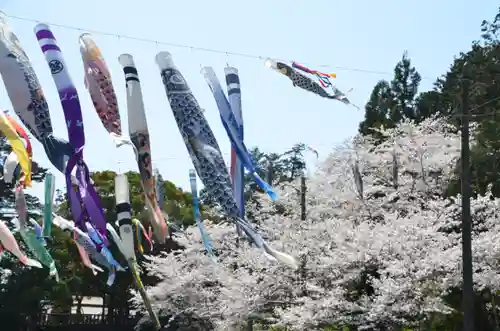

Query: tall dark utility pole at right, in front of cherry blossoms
460,78,474,331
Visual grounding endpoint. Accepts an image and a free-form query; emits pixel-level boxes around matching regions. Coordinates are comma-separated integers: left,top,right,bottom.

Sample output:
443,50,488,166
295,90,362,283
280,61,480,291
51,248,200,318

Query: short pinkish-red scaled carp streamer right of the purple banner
80,33,132,147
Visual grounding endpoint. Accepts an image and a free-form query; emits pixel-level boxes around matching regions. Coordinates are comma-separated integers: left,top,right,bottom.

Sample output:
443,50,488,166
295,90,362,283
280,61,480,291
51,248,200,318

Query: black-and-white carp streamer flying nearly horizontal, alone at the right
265,59,359,109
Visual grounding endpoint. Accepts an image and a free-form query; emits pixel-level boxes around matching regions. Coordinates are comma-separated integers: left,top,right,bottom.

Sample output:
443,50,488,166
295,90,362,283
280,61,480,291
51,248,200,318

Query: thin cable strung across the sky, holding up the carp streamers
4,13,436,81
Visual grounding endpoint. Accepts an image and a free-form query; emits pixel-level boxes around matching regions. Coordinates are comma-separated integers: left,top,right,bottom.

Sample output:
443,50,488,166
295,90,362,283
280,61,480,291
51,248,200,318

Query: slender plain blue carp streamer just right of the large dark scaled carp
202,67,277,201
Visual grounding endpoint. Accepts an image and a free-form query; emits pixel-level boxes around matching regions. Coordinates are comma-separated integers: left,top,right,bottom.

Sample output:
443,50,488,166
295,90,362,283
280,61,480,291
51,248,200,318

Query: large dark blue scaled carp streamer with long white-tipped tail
156,52,298,268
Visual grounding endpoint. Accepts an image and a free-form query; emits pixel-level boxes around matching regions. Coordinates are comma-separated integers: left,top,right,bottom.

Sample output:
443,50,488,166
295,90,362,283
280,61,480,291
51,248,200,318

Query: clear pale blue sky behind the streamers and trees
0,0,498,200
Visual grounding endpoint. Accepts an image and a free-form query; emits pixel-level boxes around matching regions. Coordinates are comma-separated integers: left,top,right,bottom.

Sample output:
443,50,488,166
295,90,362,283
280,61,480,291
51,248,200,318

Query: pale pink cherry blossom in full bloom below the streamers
136,118,500,330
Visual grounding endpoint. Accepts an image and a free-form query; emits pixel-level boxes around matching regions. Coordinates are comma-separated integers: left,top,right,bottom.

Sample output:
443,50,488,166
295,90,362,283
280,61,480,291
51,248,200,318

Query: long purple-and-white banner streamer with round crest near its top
34,23,108,246
